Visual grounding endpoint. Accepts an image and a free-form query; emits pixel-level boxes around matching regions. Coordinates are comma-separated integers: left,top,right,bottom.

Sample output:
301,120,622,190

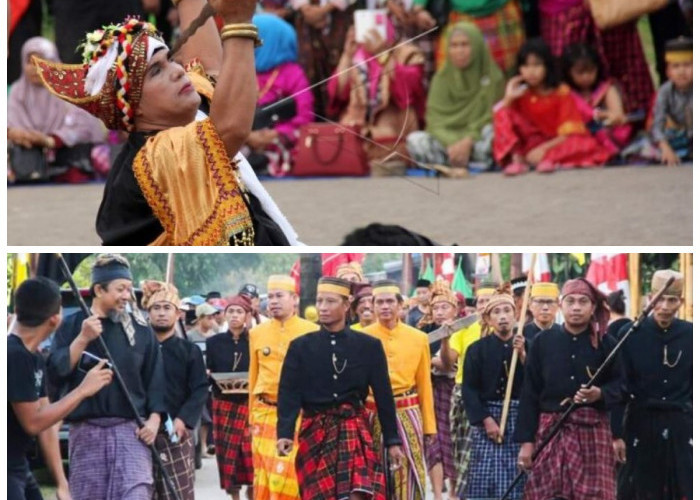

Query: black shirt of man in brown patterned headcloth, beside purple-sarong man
160,335,209,429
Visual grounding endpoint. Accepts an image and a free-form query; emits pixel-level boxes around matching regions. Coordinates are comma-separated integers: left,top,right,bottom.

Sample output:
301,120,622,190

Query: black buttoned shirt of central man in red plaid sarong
277,327,401,446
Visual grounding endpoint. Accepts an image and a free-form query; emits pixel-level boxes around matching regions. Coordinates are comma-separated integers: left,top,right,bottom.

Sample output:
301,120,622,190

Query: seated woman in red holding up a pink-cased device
327,23,425,175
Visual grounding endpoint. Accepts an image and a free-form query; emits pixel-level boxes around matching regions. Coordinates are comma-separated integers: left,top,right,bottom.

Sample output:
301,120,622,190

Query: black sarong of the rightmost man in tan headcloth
617,409,693,500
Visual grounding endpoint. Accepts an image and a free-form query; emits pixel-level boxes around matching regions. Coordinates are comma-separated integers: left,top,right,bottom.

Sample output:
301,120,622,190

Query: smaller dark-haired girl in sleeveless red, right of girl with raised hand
562,44,643,159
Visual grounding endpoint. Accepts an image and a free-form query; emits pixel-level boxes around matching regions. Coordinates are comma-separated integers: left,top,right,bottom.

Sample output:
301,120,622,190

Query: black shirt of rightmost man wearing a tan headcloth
620,317,693,412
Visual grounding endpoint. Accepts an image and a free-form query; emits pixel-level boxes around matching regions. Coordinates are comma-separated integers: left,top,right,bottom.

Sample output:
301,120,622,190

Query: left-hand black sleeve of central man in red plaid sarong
277,337,303,439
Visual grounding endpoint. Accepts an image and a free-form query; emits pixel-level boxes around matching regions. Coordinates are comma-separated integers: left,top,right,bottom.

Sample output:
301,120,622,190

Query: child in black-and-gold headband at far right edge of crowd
651,37,693,165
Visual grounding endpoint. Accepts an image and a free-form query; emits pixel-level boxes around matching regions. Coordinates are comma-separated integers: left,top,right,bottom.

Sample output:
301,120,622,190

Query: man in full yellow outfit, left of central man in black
249,276,318,500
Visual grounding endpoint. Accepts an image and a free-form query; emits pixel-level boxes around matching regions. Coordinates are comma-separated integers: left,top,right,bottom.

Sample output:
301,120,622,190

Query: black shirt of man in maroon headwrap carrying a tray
207,330,250,401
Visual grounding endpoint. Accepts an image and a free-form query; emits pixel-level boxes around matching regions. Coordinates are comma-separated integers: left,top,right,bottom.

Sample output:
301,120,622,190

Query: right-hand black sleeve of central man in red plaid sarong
369,339,401,447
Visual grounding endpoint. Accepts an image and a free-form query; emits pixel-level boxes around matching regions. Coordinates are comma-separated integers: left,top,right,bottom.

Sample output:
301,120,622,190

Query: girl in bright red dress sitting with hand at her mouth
493,38,610,175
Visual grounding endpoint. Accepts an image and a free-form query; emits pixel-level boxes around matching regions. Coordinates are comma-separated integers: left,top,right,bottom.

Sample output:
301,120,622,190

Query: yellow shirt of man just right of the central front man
363,322,437,434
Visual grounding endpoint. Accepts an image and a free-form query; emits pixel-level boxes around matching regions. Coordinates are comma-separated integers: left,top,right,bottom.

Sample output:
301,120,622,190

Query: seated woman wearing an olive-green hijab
408,22,504,177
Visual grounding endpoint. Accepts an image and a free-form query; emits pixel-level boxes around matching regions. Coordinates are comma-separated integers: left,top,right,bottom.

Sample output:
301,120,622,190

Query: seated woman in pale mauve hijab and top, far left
7,37,107,183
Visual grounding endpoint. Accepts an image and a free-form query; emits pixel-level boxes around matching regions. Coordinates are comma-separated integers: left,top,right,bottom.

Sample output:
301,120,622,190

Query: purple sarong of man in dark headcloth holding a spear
68,418,153,500
